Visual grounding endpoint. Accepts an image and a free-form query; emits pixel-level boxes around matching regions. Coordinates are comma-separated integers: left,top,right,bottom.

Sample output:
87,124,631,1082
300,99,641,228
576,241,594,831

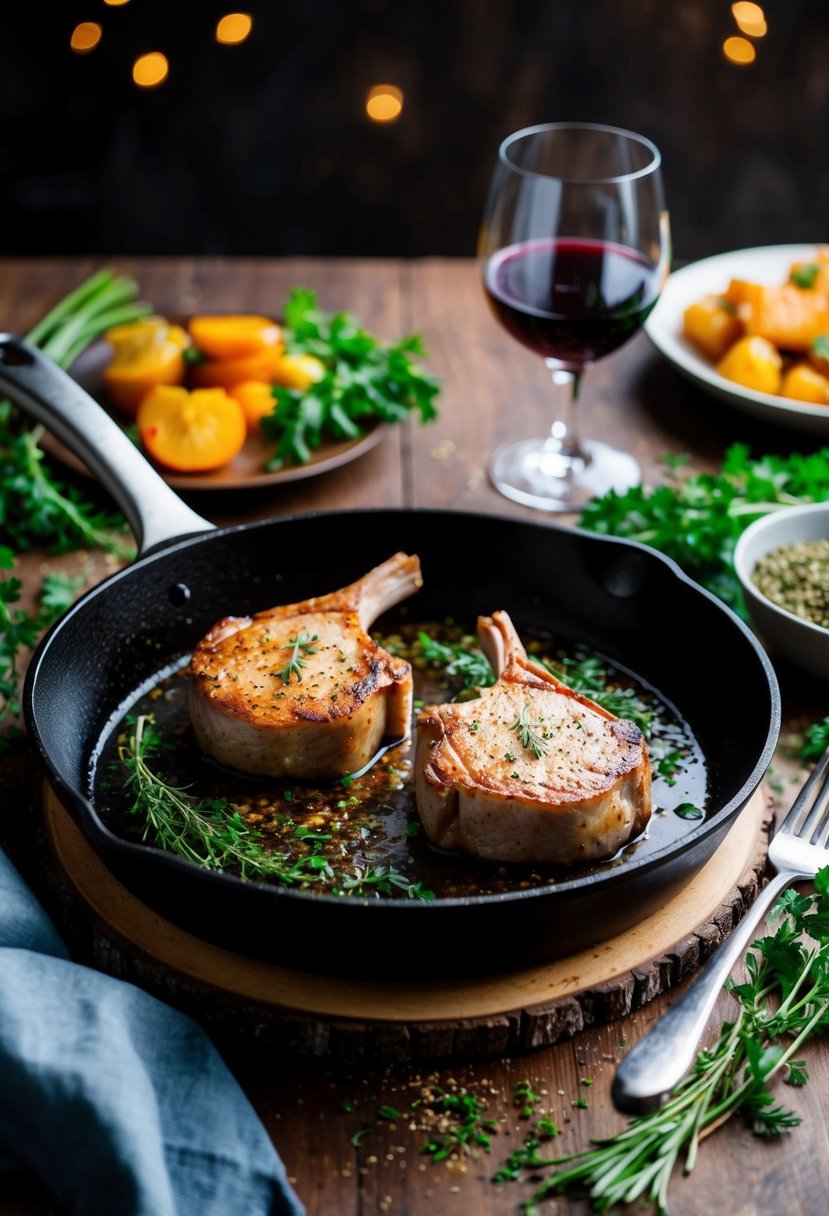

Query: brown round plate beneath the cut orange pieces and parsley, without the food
44,342,385,490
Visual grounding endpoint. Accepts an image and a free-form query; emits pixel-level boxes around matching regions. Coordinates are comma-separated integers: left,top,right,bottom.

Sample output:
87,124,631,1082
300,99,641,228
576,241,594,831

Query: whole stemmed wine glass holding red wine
479,123,670,511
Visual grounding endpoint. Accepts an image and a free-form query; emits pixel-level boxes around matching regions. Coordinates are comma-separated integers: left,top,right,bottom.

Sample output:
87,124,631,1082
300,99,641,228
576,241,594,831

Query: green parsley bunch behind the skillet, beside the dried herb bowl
579,444,829,615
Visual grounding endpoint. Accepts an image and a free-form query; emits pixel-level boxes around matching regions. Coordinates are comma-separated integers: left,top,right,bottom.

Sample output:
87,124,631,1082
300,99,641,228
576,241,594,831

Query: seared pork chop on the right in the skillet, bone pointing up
415,612,650,866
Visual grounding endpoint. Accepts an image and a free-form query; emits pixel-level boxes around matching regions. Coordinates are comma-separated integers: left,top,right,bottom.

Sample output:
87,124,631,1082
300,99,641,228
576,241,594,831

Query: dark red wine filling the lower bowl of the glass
484,238,659,368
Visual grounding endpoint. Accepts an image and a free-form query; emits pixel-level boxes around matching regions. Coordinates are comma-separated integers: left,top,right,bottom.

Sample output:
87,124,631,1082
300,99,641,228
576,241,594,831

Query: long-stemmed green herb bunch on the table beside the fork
525,867,829,1216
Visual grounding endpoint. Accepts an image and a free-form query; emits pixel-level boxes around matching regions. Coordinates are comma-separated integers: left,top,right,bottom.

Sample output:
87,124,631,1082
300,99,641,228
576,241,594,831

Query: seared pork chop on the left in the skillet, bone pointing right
190,553,423,781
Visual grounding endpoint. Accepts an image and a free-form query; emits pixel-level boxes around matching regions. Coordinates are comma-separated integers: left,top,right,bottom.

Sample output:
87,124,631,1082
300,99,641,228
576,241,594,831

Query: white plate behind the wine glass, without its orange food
644,242,829,435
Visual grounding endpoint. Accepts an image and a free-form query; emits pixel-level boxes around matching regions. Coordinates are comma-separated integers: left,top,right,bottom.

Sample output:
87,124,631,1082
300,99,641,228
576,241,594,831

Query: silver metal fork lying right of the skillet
610,748,829,1115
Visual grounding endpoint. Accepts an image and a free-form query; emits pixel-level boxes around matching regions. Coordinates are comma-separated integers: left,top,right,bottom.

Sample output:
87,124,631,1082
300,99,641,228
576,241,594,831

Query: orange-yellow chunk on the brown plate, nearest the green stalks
103,316,190,416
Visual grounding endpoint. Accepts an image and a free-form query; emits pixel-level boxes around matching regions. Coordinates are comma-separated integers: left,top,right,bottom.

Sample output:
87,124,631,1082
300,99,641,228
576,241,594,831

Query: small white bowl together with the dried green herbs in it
734,502,829,680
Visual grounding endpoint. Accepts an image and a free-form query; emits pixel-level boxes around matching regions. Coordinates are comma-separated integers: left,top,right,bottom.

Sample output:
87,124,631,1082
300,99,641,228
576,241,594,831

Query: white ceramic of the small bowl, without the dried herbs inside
734,502,829,680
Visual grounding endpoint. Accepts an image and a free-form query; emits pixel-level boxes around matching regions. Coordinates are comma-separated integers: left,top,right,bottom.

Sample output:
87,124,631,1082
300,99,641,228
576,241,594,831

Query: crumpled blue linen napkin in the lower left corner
0,851,304,1216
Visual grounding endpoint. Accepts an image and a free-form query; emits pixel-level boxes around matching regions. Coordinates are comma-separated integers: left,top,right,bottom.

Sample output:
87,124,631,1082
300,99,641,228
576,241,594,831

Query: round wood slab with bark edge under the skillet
44,789,771,1063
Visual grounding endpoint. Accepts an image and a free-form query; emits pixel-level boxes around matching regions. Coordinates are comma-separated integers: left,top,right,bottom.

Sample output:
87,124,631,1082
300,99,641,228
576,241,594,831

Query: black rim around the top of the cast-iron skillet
23,506,782,916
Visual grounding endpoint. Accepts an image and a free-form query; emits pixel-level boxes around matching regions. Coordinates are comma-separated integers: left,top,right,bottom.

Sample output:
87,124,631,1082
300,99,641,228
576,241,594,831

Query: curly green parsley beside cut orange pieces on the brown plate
261,287,439,469
